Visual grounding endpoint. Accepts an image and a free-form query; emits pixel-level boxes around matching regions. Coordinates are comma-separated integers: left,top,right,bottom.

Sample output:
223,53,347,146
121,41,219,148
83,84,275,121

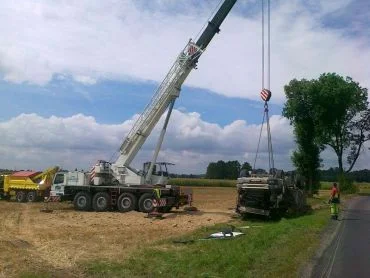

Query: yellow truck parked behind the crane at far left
2,167,59,202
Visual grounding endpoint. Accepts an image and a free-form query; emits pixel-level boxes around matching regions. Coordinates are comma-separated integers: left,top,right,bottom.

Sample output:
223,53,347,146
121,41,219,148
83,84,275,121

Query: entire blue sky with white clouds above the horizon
0,0,370,173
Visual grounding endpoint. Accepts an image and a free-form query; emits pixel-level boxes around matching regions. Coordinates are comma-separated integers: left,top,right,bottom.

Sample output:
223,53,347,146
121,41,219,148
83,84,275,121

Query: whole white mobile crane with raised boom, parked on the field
51,0,236,212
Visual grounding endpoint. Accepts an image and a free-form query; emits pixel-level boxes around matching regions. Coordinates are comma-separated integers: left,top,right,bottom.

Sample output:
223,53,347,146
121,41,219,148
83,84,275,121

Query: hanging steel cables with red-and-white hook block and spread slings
253,0,275,170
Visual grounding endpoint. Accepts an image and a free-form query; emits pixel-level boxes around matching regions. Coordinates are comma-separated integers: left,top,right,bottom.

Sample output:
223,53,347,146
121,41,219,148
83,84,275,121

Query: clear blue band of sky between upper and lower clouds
0,75,282,125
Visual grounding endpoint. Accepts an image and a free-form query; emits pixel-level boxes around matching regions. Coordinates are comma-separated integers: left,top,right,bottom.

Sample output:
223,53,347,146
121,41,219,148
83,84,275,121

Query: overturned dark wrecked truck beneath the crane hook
236,171,306,217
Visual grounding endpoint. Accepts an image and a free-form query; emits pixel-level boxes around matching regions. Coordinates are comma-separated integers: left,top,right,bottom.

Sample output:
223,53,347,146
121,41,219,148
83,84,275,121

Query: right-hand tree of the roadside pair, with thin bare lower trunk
313,73,370,174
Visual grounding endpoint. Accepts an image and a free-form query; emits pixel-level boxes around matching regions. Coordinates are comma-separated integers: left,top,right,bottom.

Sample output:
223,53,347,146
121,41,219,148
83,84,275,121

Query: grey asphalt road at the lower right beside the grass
311,196,370,278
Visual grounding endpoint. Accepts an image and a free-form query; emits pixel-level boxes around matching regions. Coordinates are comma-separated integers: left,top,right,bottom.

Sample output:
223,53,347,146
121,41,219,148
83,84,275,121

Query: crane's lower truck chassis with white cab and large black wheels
49,161,192,213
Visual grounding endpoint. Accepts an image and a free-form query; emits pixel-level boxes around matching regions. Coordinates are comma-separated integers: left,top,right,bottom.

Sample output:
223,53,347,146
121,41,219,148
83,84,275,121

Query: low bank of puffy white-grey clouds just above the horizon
0,110,370,173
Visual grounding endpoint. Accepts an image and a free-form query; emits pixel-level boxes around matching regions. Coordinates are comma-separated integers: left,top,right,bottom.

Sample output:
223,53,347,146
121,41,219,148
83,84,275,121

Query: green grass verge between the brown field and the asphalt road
85,209,329,278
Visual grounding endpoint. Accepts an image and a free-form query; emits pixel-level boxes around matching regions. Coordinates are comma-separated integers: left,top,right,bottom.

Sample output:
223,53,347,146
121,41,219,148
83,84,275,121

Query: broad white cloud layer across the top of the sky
0,0,370,102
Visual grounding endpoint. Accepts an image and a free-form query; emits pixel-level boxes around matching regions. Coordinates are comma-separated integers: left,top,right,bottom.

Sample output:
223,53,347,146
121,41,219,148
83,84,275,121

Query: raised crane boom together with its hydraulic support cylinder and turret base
94,0,236,185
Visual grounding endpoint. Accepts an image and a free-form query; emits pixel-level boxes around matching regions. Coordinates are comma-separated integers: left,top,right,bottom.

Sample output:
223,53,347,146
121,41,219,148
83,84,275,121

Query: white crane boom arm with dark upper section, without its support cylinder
115,0,236,166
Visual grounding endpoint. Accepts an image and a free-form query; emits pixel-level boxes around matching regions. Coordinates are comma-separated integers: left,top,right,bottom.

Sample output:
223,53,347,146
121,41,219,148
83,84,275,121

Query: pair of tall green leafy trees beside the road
283,73,370,185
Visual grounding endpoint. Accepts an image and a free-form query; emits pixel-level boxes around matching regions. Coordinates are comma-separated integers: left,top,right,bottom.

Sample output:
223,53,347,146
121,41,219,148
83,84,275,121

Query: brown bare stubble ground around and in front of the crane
0,187,236,277
